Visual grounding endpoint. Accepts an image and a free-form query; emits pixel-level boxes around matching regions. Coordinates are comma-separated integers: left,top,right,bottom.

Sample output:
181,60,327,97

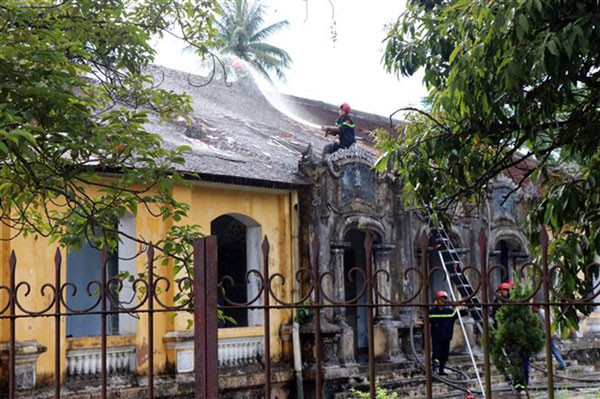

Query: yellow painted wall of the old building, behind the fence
0,180,297,384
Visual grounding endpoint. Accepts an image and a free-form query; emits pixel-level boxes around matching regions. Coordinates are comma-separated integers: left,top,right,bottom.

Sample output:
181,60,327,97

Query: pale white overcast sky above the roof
156,0,427,116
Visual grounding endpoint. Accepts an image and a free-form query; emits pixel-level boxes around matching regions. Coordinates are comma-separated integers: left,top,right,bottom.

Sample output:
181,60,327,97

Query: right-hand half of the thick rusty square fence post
204,236,219,399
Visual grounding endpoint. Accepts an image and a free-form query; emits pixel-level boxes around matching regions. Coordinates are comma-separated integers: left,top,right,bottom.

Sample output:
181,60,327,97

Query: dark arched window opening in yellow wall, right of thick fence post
210,214,262,327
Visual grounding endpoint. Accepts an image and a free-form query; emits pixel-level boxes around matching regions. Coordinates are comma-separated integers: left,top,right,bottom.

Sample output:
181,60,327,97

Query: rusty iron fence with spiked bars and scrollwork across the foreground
0,229,600,399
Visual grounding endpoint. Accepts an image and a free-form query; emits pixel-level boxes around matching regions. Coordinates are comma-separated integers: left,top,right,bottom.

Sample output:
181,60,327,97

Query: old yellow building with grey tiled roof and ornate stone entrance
0,64,598,398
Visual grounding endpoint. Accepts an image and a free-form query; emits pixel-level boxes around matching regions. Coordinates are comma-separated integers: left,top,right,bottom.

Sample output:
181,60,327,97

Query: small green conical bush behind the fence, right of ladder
490,285,544,390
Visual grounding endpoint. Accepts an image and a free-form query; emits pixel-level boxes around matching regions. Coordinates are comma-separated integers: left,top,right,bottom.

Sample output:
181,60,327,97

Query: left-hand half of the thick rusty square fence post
193,238,207,399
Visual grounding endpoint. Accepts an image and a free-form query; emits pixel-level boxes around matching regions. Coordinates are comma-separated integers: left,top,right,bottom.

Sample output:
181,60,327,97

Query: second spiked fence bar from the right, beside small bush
477,227,492,398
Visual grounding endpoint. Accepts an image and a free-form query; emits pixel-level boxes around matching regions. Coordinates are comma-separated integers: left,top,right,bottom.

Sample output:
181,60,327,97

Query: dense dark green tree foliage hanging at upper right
377,0,600,325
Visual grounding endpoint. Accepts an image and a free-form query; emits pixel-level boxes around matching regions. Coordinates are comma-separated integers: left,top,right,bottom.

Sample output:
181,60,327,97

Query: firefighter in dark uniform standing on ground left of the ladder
429,290,463,375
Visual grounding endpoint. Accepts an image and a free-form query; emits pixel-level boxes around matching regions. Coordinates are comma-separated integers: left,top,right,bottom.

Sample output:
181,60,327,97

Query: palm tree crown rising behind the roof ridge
216,0,292,81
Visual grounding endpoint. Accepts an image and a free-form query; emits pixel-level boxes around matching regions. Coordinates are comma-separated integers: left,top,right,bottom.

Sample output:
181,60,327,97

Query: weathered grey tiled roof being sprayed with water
147,67,394,188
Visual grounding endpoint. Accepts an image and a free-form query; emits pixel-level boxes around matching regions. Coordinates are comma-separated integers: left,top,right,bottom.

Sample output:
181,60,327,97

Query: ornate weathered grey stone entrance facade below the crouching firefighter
299,145,532,394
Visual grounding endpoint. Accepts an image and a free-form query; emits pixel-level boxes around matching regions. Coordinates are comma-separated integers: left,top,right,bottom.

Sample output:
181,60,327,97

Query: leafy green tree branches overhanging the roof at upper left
0,0,217,260
